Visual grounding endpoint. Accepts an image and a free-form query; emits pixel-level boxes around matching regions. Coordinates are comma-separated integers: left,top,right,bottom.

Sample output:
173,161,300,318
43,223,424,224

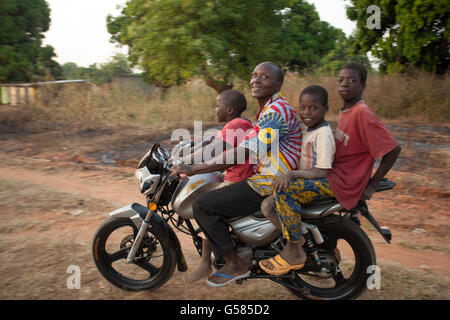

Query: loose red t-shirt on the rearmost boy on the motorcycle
327,101,398,210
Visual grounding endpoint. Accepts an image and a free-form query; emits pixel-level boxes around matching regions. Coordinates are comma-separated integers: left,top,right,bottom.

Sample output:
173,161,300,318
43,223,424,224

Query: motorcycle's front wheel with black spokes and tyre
93,218,176,291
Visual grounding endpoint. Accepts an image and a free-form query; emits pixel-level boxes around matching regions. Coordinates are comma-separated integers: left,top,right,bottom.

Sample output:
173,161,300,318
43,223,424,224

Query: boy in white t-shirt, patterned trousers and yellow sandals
259,86,336,275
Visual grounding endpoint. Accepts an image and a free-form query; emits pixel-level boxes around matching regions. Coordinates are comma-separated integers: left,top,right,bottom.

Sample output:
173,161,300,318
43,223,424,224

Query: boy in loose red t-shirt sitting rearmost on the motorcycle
327,62,401,210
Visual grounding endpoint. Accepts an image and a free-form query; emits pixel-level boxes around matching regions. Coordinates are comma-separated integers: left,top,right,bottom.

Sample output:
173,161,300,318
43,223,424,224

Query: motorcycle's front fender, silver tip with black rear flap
109,202,188,272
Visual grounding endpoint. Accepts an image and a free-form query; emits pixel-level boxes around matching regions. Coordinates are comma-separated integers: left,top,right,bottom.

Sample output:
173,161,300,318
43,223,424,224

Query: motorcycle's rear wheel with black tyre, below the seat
279,218,376,300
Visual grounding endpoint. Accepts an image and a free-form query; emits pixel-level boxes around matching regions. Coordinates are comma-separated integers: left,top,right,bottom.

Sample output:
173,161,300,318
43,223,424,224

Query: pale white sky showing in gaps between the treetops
43,0,355,67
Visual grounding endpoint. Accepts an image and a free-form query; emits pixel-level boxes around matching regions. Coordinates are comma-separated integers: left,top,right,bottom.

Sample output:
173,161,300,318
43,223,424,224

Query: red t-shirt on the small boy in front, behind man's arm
216,118,254,182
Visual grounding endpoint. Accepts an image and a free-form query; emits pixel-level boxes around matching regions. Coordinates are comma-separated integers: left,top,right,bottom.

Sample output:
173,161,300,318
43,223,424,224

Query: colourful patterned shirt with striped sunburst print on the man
240,92,302,196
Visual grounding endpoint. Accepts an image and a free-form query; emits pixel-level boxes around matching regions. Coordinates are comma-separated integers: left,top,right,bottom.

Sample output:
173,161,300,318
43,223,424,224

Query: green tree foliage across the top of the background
0,0,450,92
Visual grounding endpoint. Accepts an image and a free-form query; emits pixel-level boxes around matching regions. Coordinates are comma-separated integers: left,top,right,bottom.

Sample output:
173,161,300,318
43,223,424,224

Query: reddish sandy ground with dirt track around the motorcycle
0,110,450,300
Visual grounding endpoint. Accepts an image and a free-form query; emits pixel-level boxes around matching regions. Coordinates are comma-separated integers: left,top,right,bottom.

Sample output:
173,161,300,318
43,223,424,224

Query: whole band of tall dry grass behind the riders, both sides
26,72,450,129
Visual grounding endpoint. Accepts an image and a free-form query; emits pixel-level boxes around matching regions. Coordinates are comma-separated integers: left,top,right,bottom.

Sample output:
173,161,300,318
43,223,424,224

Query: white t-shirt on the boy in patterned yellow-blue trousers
300,122,336,170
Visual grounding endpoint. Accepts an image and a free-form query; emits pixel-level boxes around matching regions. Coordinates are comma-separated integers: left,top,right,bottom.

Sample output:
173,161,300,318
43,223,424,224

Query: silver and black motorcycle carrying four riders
92,144,395,300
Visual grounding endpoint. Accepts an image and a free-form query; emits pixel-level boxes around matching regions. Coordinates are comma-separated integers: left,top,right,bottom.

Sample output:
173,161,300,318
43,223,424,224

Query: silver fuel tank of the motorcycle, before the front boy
171,172,223,219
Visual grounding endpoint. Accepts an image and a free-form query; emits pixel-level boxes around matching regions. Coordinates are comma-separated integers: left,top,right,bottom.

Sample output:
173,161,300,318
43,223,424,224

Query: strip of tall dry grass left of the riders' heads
33,80,220,129
